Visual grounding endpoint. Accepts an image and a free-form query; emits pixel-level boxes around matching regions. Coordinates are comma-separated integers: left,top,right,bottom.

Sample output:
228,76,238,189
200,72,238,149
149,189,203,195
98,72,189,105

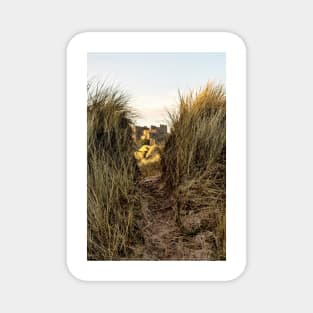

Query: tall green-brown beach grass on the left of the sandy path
87,83,140,260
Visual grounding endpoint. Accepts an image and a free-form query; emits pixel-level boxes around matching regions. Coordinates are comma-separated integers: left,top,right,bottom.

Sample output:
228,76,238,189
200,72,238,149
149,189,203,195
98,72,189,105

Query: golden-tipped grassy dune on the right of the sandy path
161,84,226,259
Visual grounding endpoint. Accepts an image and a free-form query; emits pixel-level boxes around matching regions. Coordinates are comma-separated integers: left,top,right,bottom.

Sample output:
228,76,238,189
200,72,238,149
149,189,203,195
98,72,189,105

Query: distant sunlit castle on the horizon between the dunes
133,124,167,146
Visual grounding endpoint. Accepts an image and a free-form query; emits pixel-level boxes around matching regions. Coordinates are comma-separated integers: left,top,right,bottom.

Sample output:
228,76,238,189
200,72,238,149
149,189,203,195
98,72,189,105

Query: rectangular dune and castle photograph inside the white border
86,52,227,261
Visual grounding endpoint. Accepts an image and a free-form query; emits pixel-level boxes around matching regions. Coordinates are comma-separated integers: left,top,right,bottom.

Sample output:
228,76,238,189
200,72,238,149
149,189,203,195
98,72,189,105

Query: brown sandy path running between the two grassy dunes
132,176,214,260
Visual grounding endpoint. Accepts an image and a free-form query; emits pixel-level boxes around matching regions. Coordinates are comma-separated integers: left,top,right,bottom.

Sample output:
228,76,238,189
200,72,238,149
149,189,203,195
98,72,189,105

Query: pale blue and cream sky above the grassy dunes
88,53,226,126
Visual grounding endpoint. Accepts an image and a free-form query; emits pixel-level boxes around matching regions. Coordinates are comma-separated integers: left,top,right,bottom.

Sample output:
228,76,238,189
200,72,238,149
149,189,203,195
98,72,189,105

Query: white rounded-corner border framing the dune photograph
66,32,247,281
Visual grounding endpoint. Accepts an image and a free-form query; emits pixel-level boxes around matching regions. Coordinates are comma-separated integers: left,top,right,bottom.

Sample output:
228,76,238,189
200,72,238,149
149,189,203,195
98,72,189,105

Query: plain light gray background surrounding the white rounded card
0,0,313,312
